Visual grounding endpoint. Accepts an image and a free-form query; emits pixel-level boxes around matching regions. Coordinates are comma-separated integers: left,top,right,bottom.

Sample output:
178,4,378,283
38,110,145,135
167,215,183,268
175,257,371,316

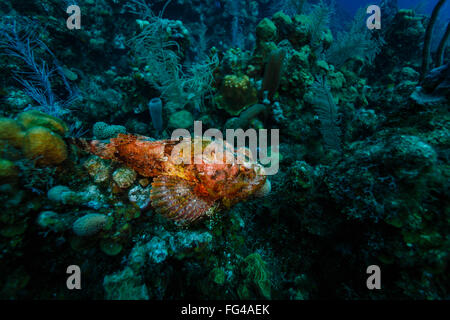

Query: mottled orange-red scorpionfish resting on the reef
73,134,270,225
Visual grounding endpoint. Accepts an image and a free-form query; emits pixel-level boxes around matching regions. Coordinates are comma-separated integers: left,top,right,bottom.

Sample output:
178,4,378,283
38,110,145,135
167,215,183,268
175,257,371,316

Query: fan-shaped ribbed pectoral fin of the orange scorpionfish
150,176,216,225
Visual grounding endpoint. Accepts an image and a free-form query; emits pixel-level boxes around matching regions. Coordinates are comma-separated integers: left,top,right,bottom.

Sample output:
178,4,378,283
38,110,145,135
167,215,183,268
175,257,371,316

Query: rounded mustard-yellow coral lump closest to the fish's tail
23,126,67,166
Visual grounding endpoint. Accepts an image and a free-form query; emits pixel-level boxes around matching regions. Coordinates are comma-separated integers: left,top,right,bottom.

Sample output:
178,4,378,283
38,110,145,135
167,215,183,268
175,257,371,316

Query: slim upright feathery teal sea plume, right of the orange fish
310,78,341,151
